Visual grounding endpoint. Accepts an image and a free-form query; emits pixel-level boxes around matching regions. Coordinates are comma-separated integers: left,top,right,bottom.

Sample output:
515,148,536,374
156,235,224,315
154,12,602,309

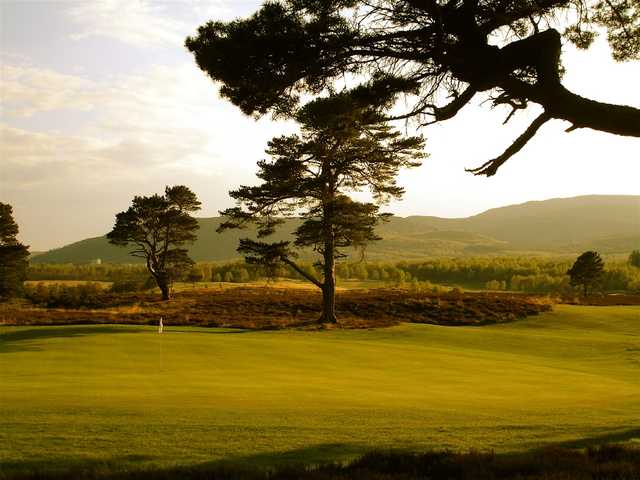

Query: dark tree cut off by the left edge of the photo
0,203,29,300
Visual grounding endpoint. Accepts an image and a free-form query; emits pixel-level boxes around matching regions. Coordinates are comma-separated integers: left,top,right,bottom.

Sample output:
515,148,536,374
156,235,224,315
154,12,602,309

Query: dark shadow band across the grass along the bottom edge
0,436,640,480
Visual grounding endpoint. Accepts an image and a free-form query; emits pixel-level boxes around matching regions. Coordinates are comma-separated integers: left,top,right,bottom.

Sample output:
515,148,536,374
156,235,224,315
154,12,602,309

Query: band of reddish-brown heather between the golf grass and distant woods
0,287,551,329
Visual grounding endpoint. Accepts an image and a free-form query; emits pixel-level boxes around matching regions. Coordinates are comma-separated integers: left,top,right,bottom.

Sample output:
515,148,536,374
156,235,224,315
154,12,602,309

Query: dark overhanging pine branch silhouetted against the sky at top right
186,0,640,176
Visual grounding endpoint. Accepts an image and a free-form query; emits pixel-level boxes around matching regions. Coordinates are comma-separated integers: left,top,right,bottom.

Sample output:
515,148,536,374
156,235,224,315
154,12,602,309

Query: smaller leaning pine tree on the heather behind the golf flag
107,185,200,300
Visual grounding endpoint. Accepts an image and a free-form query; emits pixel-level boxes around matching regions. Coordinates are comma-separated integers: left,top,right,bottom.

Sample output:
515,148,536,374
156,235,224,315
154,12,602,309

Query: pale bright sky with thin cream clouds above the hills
0,0,640,251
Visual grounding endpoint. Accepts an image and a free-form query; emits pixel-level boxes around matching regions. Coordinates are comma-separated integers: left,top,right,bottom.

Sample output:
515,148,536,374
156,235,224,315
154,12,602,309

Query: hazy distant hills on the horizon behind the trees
31,195,640,263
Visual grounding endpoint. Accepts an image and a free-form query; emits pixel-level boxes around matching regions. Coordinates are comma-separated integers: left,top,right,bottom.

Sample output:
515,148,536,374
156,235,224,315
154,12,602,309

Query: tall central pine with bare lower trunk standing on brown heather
220,88,424,323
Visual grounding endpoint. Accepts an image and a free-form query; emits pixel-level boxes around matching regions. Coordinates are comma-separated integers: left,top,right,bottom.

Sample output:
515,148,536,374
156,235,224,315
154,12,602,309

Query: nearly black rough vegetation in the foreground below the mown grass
5,445,640,480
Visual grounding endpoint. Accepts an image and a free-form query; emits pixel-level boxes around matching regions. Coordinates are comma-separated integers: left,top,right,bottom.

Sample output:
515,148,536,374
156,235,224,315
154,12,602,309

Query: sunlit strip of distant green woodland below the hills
28,257,640,293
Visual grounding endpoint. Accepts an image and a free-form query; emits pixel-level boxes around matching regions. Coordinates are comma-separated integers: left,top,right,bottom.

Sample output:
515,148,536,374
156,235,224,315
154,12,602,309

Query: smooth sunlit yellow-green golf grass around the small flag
0,306,640,472
